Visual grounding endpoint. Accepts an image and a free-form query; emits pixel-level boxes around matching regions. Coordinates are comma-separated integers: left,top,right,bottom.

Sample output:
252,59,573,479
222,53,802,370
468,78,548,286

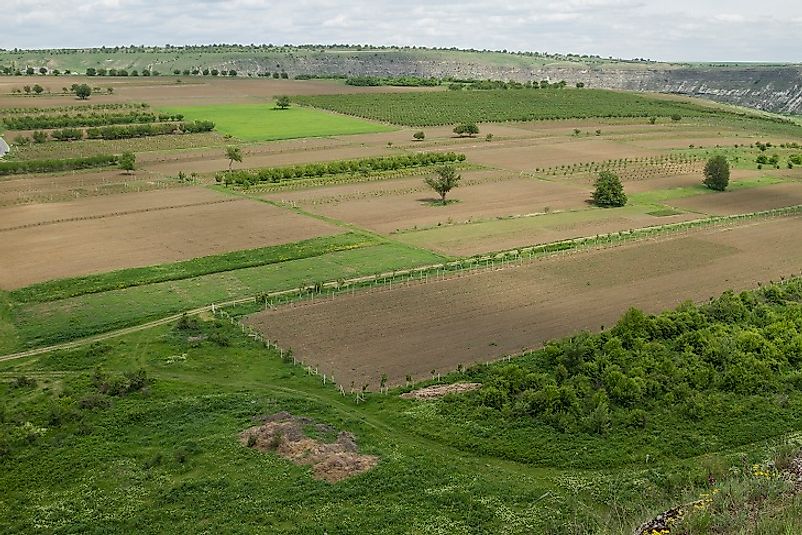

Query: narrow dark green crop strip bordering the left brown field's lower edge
10,232,378,303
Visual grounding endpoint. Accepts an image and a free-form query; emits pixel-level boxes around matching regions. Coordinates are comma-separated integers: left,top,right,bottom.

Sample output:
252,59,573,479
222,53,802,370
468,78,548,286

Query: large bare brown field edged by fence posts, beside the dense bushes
247,217,802,389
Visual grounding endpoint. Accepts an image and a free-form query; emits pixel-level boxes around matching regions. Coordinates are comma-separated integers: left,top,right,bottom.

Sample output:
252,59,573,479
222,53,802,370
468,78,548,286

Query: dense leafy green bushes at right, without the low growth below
456,280,802,440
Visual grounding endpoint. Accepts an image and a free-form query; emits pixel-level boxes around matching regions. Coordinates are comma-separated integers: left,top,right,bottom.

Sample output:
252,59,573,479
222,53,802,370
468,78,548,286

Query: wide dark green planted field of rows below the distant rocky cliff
294,89,748,126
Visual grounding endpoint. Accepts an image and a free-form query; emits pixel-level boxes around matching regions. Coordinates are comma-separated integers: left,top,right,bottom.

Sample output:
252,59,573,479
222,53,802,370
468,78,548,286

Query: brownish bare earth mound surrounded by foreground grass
240,412,379,483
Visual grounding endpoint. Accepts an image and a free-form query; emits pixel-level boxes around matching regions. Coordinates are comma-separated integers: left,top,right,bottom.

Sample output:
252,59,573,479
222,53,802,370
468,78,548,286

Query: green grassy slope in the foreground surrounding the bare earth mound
0,306,788,534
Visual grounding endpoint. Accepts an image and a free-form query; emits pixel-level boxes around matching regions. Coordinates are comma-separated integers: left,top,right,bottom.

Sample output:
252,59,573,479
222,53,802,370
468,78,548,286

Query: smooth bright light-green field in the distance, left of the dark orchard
160,104,393,141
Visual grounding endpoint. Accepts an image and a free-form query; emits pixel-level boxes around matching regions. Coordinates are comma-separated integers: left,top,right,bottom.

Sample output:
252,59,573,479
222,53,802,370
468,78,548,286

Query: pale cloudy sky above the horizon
6,0,802,62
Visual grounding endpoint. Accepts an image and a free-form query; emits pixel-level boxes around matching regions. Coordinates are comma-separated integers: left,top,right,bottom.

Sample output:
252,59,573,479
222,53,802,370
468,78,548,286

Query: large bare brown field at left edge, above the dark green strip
0,188,339,289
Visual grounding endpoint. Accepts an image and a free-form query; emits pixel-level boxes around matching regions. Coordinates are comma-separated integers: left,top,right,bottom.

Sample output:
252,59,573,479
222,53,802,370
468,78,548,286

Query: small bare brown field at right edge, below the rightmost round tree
669,183,802,215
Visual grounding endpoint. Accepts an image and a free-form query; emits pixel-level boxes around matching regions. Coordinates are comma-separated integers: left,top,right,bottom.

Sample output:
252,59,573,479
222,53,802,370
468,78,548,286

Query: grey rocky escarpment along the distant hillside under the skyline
223,51,802,114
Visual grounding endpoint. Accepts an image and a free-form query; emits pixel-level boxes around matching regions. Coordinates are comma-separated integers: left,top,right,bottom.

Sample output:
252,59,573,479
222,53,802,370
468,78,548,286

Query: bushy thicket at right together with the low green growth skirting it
400,279,802,468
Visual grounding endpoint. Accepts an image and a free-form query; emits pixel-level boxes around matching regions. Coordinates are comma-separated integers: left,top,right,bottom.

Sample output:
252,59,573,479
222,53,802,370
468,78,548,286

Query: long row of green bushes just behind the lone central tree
216,152,465,184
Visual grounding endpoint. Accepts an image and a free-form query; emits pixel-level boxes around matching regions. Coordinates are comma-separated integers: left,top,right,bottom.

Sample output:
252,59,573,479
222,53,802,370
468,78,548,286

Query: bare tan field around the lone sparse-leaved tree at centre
266,171,590,233
